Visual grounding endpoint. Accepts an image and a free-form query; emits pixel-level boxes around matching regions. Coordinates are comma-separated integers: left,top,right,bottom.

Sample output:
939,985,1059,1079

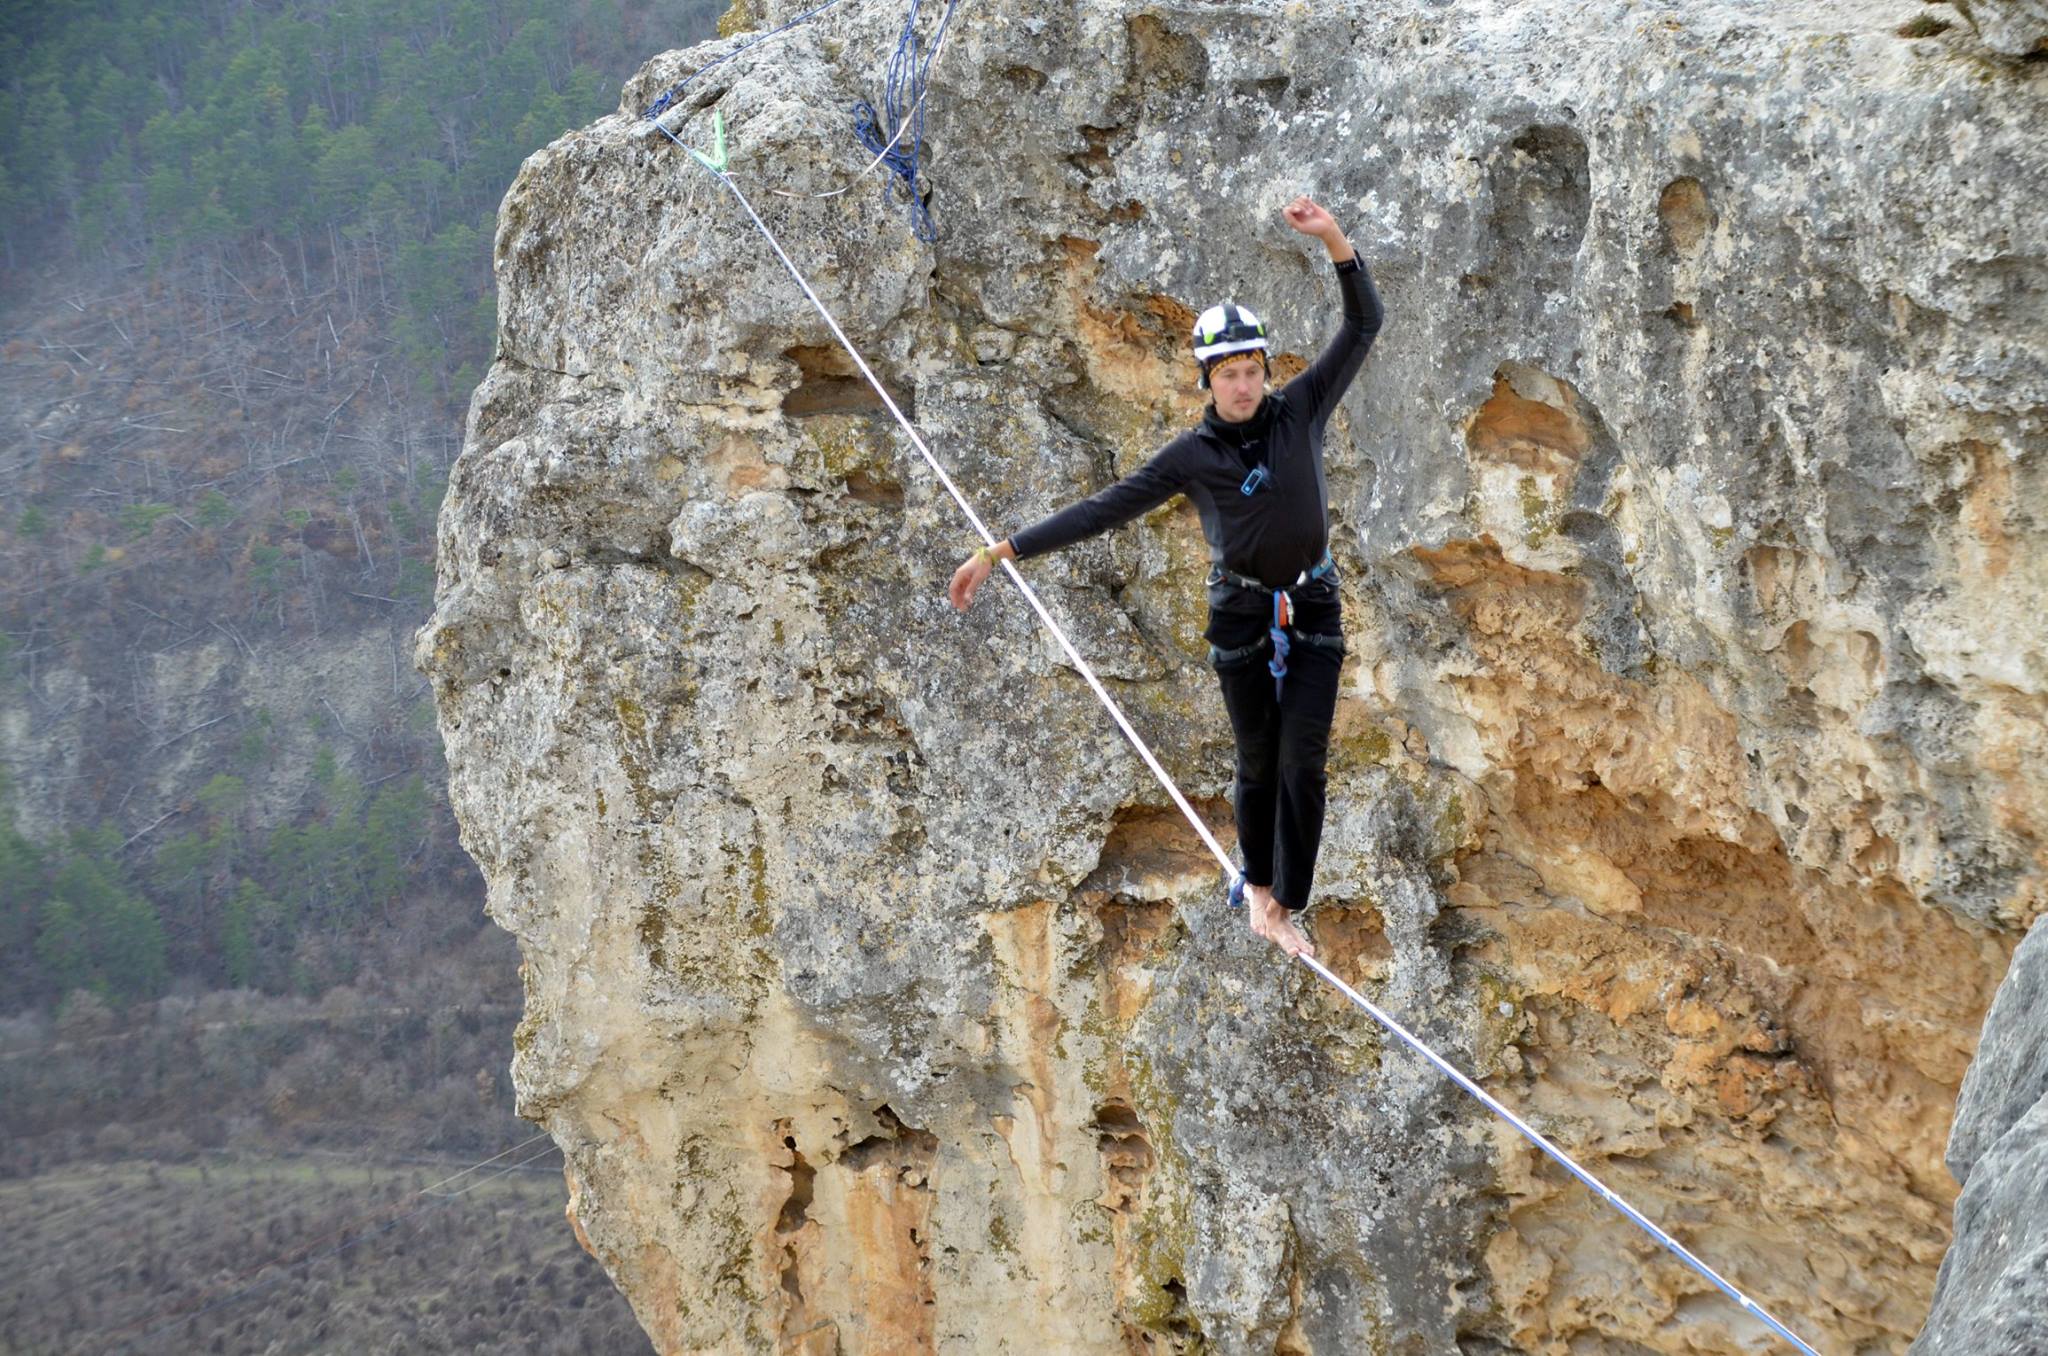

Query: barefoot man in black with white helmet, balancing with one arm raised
946,197,1382,957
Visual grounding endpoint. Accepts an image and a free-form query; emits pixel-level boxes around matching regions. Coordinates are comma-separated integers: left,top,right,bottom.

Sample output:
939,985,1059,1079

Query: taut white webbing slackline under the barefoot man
684,156,1821,1356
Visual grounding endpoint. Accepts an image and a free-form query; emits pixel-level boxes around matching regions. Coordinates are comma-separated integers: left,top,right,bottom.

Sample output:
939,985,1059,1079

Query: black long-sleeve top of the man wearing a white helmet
1010,256,1384,588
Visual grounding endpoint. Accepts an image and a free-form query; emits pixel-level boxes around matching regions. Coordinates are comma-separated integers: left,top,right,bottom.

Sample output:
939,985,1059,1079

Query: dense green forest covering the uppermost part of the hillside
0,0,721,399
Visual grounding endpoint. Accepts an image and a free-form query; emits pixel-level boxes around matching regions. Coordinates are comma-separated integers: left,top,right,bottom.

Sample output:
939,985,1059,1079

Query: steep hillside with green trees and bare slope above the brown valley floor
0,0,719,1012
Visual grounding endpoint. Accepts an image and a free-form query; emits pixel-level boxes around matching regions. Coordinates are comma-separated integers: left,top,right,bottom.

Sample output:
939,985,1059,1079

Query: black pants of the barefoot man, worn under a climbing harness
1204,576,1343,909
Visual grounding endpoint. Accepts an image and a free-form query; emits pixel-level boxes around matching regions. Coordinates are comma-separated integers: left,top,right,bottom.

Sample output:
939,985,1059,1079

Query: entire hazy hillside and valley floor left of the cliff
0,0,723,1352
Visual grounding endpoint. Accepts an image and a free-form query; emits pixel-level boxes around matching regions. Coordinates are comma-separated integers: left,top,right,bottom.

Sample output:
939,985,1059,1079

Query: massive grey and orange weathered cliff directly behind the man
420,0,2048,1356
